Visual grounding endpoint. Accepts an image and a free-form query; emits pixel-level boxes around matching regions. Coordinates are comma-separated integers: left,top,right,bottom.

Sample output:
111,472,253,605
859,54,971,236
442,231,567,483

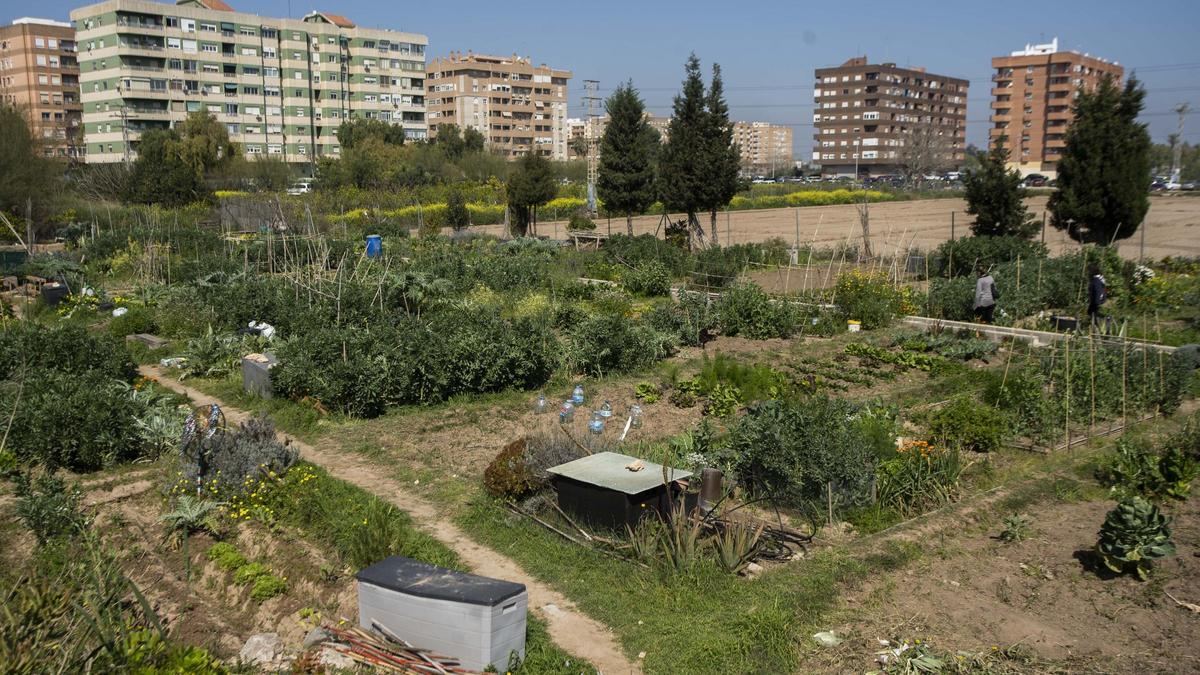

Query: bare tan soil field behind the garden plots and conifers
476,195,1200,258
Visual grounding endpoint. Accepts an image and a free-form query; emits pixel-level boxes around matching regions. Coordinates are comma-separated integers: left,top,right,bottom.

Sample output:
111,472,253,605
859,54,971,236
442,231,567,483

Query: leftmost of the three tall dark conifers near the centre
596,82,659,235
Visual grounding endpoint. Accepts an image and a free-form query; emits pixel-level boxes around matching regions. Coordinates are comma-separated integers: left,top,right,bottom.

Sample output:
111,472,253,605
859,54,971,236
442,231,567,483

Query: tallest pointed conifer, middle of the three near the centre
659,54,708,243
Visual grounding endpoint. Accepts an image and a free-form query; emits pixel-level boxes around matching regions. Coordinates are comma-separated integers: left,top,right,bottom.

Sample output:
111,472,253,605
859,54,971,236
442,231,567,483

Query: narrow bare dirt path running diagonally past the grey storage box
139,365,641,674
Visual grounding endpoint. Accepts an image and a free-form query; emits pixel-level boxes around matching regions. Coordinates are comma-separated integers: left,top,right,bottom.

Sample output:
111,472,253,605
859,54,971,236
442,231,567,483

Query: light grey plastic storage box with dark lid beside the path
356,556,529,671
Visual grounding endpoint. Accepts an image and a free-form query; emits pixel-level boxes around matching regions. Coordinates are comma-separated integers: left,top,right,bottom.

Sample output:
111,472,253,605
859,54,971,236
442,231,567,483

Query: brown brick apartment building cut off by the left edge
0,18,83,160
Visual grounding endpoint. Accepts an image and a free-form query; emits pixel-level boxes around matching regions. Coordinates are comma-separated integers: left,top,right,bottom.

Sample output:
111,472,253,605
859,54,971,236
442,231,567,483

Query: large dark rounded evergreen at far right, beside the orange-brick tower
1049,76,1150,245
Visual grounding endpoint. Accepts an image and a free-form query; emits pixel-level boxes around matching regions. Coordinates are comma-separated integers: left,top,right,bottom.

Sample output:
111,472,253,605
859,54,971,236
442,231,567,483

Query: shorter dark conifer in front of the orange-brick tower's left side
962,136,1037,238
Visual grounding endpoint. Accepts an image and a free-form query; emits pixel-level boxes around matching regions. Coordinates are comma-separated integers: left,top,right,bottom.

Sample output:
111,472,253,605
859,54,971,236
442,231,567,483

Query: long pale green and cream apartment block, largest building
71,0,428,163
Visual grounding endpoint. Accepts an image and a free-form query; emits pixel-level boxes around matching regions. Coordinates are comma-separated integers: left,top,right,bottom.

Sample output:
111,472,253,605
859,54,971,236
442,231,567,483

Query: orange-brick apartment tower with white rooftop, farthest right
989,37,1124,178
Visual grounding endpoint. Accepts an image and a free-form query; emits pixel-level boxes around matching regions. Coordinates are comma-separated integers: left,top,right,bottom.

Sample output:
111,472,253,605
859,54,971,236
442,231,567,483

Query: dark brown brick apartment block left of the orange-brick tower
812,56,968,177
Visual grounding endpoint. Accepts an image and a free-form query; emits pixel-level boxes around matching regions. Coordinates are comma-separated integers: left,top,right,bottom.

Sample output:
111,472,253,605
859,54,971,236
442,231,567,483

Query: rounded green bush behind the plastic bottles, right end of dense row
568,313,676,376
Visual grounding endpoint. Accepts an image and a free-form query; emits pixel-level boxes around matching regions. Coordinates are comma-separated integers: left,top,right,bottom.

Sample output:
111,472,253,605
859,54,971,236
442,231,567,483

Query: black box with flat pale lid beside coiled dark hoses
547,453,691,528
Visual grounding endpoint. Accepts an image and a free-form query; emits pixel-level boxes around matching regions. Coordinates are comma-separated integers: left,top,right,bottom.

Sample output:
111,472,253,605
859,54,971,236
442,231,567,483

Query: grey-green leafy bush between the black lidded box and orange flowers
725,396,875,509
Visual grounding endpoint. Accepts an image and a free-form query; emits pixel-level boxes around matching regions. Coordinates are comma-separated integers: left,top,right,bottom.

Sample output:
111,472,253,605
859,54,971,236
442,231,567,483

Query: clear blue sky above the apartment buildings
11,0,1200,153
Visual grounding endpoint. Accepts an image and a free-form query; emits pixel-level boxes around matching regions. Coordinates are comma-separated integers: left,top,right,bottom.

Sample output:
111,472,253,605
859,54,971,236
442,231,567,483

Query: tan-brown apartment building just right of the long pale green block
425,52,571,160
